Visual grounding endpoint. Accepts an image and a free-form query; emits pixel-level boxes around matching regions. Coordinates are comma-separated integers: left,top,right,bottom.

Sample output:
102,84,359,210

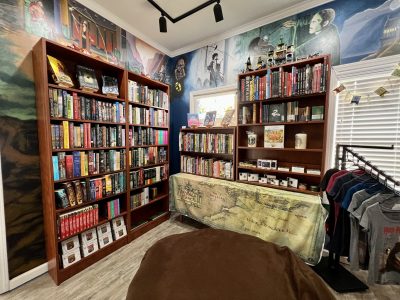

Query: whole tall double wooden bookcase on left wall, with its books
33,39,169,284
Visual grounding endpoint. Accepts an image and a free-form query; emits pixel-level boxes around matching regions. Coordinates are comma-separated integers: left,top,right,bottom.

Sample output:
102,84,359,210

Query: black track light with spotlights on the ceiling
147,0,224,32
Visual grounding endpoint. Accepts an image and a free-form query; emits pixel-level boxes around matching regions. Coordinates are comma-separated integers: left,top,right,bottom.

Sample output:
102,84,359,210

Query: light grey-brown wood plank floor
0,219,400,300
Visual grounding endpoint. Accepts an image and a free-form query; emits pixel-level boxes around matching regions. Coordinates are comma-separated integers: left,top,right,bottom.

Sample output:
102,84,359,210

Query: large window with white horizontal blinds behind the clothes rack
334,57,400,180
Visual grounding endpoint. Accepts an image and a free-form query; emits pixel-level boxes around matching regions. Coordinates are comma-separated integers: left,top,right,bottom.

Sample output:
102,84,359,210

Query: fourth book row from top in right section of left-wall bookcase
129,147,167,167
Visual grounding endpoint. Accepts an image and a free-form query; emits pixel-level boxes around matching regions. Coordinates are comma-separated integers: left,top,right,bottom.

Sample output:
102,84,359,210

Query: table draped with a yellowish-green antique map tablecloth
169,173,327,265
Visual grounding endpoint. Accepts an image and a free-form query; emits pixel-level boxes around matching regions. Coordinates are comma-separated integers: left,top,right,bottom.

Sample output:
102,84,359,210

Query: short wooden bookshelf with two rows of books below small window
179,127,236,181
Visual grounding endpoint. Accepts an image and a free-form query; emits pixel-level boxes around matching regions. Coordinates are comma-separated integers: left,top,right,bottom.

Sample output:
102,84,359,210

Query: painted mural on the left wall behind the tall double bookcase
0,0,169,278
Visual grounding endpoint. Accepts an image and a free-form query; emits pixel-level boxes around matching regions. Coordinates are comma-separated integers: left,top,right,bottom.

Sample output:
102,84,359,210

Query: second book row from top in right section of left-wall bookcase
129,105,168,127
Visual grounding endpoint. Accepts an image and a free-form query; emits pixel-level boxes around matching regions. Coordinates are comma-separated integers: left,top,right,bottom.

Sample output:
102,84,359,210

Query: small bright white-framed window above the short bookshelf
190,86,237,126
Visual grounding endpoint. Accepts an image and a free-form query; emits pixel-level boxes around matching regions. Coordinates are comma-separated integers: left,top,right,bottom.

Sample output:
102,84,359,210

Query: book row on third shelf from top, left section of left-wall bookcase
51,121,125,149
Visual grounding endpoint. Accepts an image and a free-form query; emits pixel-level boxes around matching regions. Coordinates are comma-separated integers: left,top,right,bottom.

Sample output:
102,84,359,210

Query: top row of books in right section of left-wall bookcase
128,80,169,108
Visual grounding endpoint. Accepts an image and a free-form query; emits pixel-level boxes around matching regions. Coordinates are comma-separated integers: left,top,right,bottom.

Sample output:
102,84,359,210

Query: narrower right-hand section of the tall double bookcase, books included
127,72,169,241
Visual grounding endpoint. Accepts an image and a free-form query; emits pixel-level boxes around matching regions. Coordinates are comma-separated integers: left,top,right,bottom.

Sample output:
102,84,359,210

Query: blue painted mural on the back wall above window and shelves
171,0,400,173
